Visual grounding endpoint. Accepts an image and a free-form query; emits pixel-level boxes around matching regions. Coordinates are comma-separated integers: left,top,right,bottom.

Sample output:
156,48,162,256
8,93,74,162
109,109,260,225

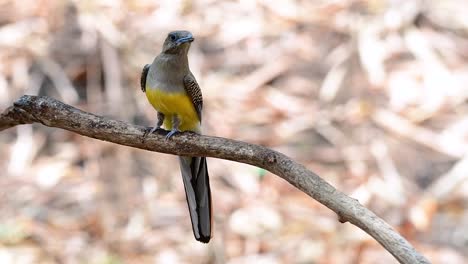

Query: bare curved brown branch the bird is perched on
0,95,429,264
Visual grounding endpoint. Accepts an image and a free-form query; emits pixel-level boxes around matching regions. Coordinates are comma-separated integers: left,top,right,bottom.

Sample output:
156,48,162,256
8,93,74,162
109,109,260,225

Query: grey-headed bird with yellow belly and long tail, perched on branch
140,30,213,243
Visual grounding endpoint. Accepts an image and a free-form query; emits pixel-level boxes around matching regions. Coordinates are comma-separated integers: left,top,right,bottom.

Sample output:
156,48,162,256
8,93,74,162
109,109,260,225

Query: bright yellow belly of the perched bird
146,88,200,131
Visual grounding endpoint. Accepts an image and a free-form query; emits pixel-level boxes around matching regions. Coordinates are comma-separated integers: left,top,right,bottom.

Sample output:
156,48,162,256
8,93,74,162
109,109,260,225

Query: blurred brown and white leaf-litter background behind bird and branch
0,0,468,264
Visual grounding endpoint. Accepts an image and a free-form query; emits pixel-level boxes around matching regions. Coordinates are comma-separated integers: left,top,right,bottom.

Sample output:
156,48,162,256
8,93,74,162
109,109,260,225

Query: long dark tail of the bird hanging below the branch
179,157,212,243
